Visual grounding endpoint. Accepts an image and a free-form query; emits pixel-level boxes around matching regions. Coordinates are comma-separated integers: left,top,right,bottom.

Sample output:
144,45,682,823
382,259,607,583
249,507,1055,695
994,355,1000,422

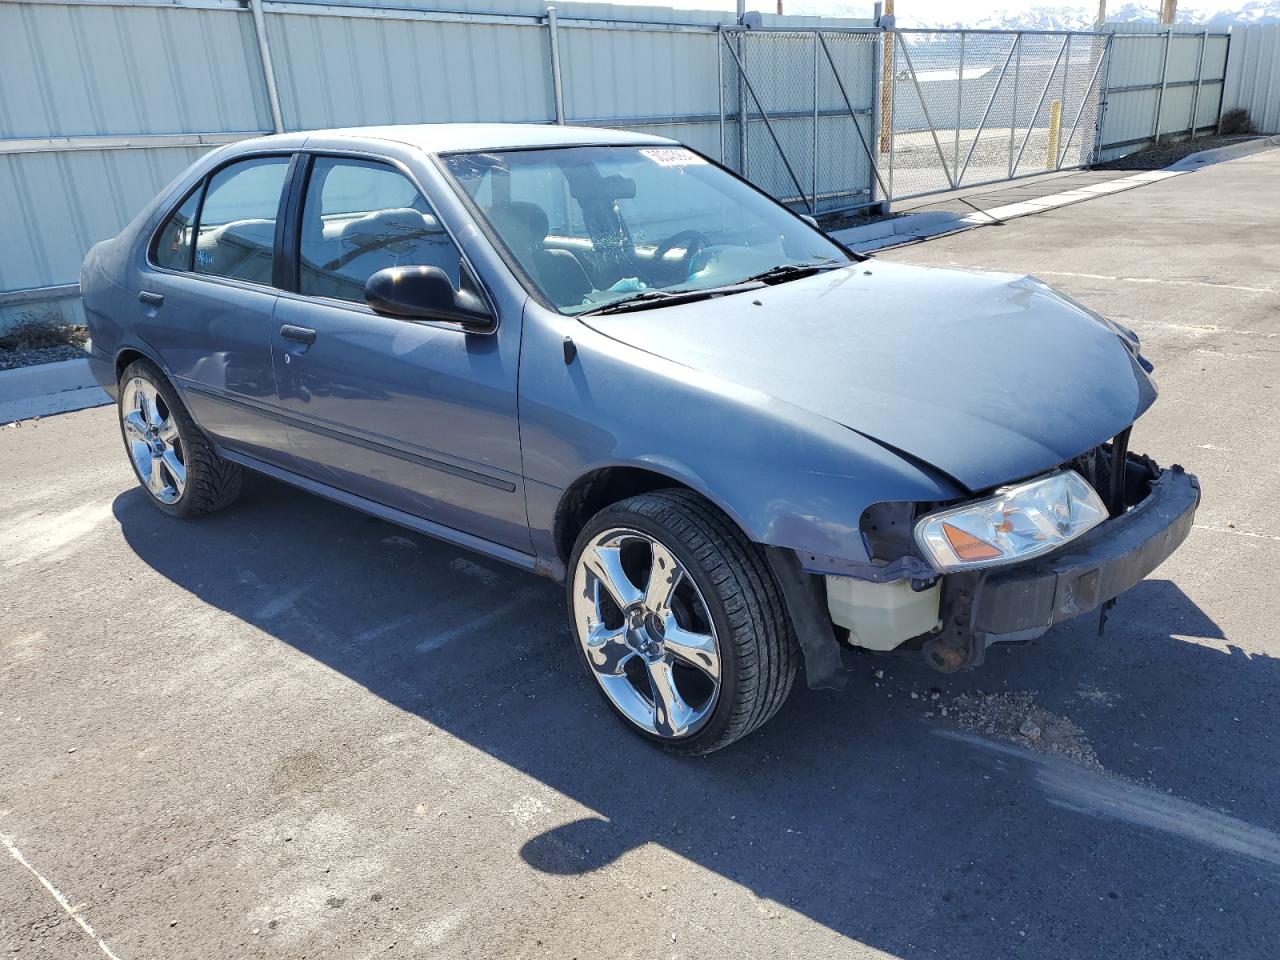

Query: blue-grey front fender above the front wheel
520,303,964,562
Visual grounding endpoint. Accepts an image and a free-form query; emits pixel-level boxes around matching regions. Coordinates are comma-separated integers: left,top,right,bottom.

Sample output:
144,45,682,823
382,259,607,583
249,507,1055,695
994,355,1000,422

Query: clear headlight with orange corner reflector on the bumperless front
915,470,1107,573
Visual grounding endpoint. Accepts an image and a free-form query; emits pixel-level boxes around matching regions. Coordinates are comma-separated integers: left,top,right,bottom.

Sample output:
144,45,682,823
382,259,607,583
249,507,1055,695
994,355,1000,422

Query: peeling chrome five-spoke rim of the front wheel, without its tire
573,527,721,739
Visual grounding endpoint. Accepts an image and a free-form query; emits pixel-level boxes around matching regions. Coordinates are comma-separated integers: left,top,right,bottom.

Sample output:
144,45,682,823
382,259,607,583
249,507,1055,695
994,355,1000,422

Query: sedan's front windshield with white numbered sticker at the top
443,146,849,314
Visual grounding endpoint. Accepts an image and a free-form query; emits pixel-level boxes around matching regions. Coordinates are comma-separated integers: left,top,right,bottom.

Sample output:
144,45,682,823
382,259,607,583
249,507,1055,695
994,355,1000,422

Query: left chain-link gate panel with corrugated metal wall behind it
719,29,888,214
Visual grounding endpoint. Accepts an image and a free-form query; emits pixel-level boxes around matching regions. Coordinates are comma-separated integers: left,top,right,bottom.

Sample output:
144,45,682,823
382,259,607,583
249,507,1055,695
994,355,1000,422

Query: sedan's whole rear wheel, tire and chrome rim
116,360,242,518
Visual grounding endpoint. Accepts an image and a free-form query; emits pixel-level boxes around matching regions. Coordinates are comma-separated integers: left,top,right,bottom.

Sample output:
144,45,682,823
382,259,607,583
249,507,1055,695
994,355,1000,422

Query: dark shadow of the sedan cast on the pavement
114,479,1280,957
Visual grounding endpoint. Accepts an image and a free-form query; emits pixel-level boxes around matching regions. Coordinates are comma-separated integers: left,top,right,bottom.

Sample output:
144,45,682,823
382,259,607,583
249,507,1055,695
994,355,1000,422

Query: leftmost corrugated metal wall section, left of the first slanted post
0,3,270,326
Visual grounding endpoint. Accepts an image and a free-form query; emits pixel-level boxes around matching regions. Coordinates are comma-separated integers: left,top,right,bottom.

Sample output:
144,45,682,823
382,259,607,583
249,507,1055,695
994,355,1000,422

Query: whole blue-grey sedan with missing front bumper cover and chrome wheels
81,124,1199,753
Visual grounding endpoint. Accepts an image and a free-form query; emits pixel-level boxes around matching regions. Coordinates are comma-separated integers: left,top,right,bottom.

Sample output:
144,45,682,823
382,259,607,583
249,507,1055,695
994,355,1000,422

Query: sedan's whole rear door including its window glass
137,154,292,466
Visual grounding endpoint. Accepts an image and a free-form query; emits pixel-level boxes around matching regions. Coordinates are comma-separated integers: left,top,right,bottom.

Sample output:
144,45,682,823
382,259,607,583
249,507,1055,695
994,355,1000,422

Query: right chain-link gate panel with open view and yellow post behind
878,29,1110,198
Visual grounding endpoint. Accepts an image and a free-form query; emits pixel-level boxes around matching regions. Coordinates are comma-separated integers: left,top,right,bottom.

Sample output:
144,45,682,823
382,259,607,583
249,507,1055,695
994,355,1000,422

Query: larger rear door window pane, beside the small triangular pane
195,156,289,284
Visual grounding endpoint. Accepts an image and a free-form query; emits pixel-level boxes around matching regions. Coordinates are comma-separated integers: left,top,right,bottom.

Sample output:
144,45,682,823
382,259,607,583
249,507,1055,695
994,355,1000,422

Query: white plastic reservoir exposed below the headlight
827,576,942,650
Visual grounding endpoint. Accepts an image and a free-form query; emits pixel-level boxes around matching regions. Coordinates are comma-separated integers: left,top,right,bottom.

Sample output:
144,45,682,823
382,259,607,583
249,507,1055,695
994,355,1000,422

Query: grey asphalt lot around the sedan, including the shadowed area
0,151,1280,960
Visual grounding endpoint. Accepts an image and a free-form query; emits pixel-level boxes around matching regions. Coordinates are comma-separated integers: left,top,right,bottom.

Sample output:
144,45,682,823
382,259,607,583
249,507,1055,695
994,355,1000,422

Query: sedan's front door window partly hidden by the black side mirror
298,156,462,303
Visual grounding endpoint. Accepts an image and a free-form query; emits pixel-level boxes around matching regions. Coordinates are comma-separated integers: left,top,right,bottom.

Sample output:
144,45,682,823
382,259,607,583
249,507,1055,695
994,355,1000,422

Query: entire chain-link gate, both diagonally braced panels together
719,29,1112,214
